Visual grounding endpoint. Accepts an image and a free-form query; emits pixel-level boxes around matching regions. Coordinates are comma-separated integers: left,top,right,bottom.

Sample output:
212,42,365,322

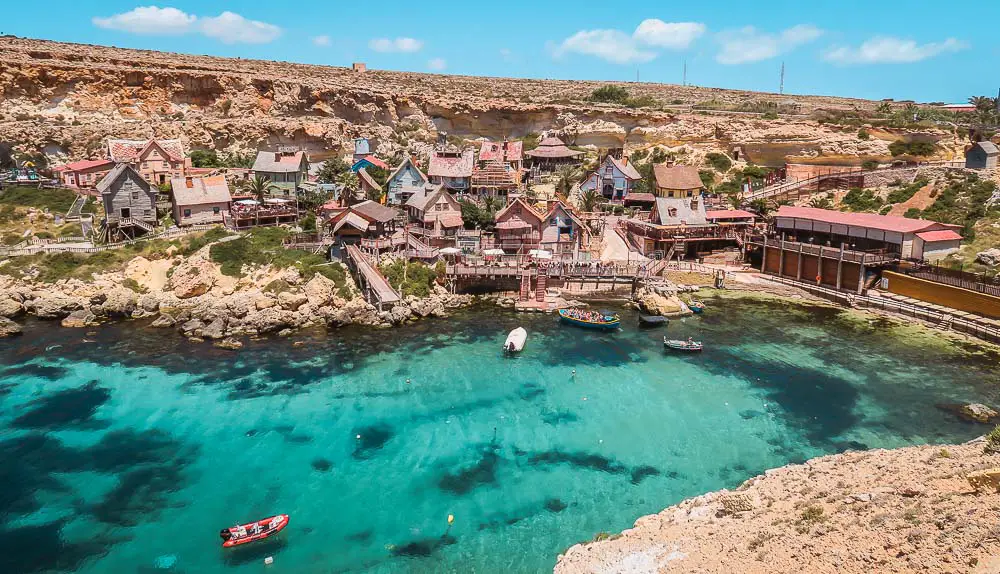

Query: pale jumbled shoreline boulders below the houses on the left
0,264,473,349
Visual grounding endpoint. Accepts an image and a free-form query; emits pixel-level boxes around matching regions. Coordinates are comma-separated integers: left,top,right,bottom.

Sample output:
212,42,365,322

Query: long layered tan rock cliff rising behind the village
0,36,952,163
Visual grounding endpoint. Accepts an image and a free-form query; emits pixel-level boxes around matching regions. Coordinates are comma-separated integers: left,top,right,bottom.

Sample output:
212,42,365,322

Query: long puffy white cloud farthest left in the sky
92,6,281,44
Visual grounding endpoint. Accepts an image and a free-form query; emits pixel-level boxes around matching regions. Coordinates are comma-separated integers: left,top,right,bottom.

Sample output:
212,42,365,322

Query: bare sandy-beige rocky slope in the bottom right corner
555,440,1000,574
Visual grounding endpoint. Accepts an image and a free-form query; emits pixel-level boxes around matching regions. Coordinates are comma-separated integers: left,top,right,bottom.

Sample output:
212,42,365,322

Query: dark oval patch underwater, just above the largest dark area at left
11,381,111,429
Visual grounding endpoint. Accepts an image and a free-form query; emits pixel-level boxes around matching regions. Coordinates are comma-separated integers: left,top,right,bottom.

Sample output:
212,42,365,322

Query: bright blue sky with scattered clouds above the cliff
0,0,1000,103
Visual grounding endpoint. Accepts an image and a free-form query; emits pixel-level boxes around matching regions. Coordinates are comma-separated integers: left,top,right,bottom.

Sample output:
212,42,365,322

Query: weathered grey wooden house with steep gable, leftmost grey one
97,163,157,240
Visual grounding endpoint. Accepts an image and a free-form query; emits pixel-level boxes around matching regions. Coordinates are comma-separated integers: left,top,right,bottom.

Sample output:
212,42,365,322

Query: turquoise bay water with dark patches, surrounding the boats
0,301,1000,574
